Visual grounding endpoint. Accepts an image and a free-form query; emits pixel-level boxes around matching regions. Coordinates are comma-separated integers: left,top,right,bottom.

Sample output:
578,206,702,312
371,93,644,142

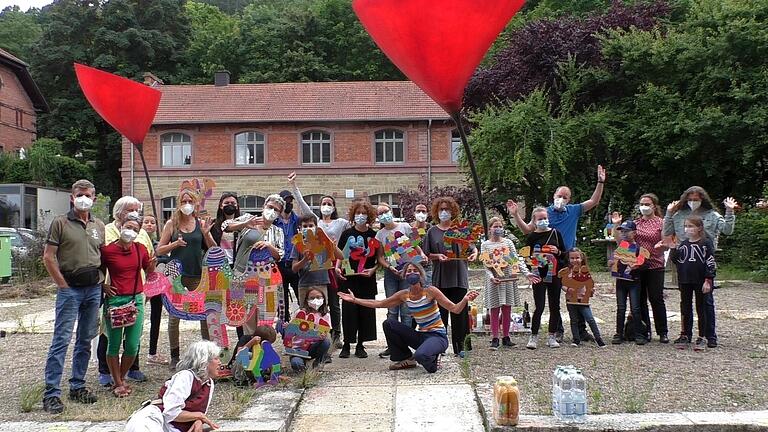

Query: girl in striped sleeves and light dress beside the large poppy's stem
480,217,541,351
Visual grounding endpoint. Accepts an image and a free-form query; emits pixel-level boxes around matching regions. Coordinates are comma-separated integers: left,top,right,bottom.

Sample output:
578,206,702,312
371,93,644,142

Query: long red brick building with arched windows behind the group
121,74,465,221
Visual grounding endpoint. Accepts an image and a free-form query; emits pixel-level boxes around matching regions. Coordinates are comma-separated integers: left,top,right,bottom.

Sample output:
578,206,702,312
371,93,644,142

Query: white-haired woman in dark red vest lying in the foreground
125,341,221,432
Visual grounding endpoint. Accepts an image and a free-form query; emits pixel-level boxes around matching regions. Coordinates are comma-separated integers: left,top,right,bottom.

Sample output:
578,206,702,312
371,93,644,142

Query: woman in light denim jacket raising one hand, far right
664,186,738,348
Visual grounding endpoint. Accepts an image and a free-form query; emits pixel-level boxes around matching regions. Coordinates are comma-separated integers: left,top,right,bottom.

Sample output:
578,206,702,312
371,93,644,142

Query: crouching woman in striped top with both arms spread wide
339,263,478,373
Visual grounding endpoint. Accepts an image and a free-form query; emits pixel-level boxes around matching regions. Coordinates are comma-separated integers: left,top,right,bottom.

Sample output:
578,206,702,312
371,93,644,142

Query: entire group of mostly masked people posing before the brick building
43,167,736,430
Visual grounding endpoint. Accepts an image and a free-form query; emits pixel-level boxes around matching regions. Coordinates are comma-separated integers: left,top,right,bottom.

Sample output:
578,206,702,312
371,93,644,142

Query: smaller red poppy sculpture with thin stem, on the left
75,63,162,219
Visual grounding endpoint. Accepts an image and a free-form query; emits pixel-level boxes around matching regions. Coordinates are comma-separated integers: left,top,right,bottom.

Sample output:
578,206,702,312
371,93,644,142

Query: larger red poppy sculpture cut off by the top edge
352,0,524,232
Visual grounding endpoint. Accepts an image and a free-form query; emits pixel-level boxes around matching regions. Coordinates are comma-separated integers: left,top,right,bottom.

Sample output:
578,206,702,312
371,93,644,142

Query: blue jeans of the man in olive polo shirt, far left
43,284,101,398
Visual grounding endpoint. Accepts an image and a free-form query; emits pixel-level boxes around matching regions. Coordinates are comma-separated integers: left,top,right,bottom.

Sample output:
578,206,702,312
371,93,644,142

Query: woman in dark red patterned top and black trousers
611,193,669,343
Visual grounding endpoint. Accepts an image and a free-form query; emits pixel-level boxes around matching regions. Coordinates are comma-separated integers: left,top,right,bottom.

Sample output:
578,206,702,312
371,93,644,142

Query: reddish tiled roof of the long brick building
154,81,450,125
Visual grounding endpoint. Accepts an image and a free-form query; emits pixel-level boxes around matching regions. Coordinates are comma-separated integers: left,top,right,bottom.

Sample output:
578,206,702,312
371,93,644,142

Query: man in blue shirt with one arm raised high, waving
507,165,605,342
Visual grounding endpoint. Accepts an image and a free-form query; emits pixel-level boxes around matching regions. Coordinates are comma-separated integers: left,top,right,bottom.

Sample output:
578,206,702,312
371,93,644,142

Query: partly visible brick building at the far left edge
0,49,48,153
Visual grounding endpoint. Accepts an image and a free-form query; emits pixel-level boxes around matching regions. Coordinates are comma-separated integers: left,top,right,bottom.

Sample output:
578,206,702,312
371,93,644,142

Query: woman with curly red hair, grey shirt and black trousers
421,197,477,355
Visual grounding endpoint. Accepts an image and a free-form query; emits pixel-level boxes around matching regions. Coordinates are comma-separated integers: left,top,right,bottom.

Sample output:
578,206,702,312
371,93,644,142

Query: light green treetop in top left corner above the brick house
0,6,43,61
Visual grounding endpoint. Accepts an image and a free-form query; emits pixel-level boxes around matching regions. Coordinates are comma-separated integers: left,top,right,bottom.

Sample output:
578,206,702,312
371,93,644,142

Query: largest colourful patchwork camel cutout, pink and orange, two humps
163,247,283,347
